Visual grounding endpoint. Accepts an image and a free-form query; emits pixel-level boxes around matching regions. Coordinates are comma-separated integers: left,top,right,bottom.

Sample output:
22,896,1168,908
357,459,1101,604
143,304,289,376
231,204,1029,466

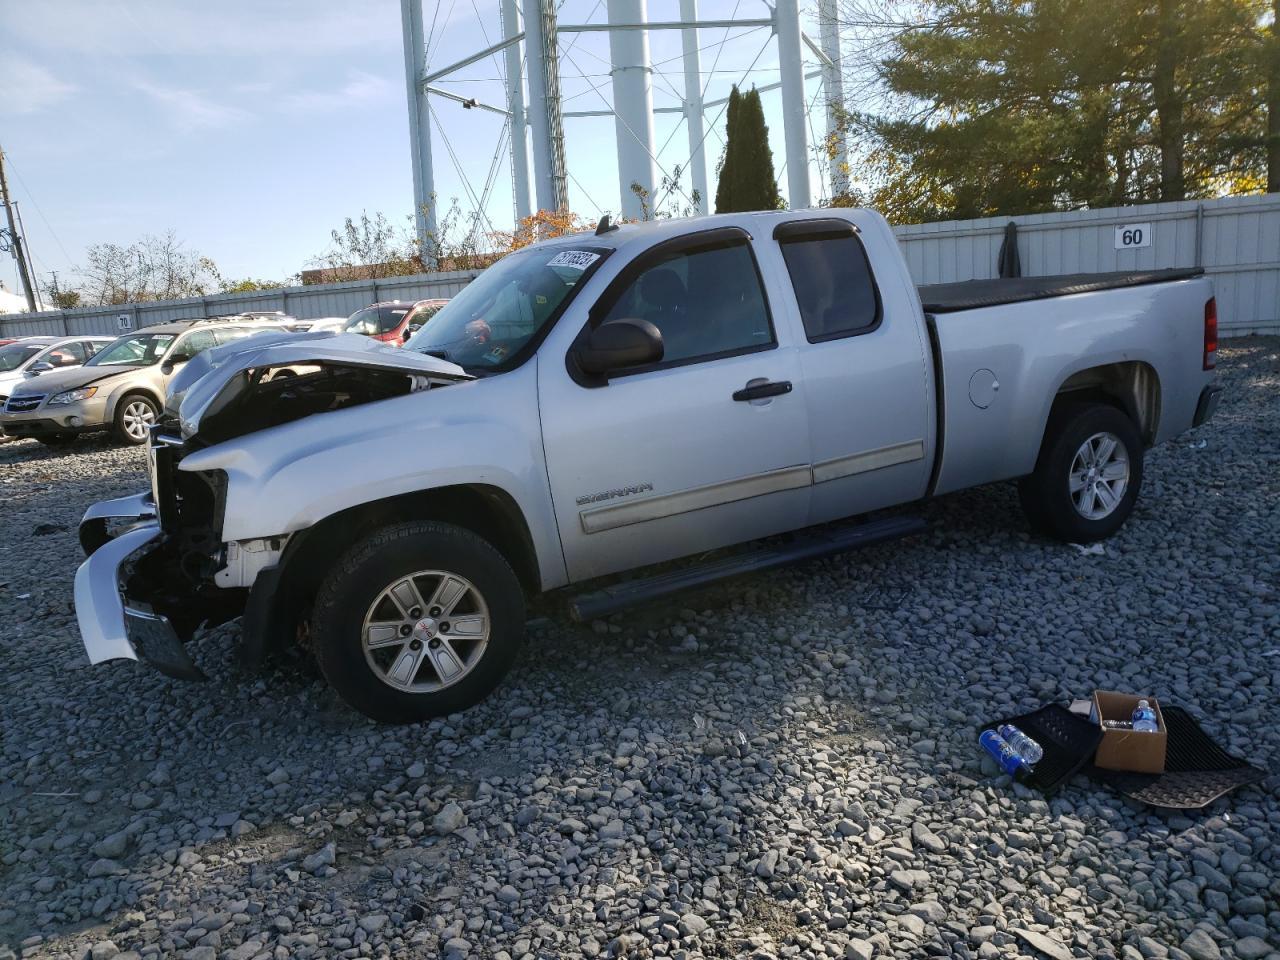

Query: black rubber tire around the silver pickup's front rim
310,521,525,723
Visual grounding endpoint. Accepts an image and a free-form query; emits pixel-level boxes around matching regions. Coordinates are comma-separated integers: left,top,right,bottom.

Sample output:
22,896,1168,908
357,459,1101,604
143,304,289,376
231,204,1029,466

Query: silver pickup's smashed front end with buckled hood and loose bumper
76,334,470,680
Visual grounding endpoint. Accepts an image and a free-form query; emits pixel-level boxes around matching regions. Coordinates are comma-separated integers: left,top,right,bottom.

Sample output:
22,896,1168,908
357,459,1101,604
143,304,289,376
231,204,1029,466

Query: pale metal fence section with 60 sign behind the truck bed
895,193,1280,337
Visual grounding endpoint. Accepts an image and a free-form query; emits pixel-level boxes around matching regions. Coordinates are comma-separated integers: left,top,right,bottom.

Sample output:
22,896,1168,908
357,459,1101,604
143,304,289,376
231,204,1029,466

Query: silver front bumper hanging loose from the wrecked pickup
76,494,205,680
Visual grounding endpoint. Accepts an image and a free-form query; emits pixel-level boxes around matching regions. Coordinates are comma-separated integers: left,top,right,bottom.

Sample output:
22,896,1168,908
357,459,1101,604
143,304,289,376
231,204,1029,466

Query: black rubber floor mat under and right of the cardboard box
1088,707,1267,810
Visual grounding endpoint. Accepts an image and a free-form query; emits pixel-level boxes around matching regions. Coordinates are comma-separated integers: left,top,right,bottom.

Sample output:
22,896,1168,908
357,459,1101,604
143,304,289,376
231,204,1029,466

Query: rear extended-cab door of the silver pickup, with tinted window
772,218,934,524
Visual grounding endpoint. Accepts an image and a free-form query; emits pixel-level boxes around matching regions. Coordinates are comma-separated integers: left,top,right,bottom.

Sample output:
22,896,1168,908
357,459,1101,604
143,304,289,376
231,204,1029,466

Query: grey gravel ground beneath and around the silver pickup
0,338,1280,960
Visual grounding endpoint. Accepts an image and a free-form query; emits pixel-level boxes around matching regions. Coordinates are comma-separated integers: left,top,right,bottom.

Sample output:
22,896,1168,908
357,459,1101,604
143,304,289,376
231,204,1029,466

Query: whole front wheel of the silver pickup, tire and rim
310,522,525,723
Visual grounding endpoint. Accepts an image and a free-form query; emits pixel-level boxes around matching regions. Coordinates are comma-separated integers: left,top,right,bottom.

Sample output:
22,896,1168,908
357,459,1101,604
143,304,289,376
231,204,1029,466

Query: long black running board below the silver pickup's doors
568,517,925,622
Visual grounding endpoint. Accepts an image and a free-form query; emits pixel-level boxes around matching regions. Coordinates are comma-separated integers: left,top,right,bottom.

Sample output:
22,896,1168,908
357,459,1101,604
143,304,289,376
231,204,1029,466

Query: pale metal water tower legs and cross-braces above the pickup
401,0,847,256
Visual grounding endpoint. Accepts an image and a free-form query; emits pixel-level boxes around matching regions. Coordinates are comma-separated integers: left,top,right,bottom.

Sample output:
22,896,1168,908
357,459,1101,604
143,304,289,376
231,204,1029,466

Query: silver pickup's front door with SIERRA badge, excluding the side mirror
539,228,810,581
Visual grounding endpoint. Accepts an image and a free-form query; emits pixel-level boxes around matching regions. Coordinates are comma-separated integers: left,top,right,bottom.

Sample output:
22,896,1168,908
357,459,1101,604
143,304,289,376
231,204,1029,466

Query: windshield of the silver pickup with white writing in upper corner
404,246,608,370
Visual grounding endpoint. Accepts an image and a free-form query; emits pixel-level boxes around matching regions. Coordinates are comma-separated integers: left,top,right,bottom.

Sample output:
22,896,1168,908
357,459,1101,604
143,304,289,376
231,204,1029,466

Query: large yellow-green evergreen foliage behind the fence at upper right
846,0,1280,221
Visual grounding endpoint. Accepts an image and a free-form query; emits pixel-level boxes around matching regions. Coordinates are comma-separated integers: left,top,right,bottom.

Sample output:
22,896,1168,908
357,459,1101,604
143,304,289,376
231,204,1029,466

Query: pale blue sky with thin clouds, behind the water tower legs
0,0,839,289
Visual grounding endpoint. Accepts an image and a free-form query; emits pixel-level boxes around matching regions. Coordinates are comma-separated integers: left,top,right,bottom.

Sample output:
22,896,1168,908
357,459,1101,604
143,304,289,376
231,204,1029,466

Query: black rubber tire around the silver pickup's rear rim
1018,403,1143,543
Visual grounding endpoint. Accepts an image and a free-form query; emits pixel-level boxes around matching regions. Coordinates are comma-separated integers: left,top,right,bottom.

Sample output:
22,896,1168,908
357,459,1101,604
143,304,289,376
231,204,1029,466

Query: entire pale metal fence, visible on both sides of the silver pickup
0,193,1280,337
